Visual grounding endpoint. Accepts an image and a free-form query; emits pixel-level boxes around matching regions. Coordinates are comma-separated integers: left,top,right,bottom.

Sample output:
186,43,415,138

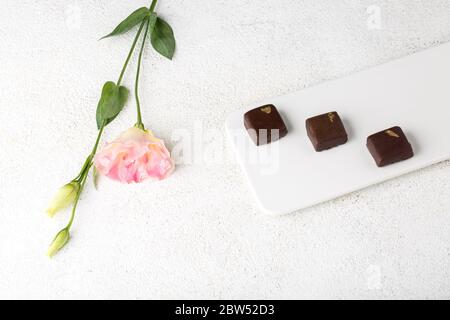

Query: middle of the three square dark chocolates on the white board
306,112,348,152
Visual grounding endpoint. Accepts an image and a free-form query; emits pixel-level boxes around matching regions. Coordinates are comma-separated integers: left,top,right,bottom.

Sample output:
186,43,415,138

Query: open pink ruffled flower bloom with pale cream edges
94,127,175,183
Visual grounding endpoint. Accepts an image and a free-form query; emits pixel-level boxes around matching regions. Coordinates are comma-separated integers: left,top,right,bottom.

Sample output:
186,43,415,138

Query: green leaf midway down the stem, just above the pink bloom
96,81,128,129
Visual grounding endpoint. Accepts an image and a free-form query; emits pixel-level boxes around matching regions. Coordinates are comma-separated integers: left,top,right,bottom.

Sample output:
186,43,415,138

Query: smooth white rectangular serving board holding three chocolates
226,43,450,214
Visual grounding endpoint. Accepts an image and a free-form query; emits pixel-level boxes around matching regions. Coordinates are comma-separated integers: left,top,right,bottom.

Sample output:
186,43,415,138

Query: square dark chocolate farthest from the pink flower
367,127,414,167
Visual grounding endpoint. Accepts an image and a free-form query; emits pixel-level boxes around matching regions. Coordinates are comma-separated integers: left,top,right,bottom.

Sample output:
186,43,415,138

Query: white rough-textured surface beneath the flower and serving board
0,0,450,299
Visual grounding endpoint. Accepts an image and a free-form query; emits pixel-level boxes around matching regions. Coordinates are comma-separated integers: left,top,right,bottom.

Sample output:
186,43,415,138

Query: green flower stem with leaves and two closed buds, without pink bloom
48,0,175,256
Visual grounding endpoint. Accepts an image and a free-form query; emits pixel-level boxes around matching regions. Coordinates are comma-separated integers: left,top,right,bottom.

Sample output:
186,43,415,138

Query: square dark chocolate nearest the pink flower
244,104,288,146
